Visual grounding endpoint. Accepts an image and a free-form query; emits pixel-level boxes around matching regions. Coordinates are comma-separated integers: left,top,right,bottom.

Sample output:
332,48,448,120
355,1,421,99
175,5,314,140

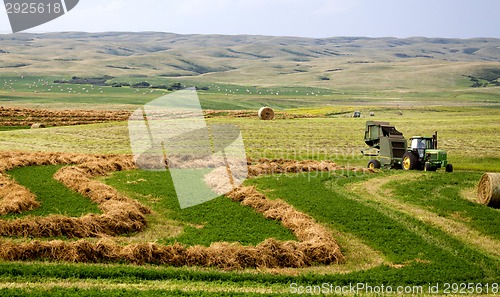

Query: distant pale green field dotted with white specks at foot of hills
0,71,500,110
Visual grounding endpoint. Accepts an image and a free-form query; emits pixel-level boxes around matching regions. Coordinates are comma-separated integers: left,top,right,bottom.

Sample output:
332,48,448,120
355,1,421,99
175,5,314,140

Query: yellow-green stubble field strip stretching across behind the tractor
0,108,500,171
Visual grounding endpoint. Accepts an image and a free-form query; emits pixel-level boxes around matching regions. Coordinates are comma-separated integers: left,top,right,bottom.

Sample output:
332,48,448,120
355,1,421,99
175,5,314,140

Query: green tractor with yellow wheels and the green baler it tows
361,121,453,172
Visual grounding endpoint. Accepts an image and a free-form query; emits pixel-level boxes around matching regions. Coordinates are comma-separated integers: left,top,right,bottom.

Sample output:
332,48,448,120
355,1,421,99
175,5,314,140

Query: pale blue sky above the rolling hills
0,0,500,38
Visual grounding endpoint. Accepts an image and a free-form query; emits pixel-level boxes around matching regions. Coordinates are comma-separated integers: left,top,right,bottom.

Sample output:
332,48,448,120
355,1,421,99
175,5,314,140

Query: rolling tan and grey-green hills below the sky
0,32,500,89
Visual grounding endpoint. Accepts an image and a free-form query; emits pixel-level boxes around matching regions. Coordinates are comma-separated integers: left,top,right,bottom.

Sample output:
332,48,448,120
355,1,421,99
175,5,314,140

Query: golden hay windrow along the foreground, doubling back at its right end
0,187,344,269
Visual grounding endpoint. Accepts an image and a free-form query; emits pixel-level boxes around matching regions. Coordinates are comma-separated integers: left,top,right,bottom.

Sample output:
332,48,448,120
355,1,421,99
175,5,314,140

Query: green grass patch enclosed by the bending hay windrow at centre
105,171,295,246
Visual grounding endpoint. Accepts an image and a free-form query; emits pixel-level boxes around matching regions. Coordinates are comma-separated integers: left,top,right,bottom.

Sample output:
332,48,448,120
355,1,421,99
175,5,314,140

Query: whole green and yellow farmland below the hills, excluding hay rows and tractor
0,68,500,296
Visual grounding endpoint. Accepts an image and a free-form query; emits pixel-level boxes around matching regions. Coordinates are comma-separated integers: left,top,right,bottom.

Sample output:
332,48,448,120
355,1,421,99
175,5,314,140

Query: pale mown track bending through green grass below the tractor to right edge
348,173,500,259
